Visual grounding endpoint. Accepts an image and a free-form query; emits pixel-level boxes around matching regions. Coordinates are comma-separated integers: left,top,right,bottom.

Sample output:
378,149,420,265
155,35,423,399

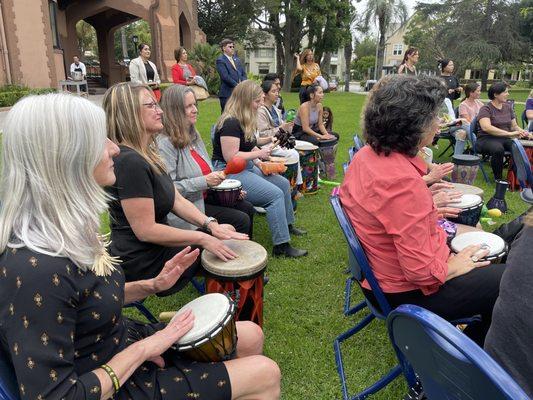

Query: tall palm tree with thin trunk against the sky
363,0,407,79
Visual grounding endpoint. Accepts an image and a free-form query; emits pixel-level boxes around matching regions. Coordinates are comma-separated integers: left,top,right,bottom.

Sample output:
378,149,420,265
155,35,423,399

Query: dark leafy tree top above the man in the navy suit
198,0,260,44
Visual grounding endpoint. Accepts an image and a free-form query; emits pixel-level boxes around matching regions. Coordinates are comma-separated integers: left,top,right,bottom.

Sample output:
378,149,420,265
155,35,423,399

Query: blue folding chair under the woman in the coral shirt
330,188,416,400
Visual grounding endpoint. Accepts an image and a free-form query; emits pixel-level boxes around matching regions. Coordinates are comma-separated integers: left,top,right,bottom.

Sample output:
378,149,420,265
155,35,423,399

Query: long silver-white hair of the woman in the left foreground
0,94,108,271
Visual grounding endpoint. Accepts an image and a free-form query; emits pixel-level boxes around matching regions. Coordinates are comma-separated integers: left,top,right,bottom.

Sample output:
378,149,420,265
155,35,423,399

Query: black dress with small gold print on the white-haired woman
0,248,231,400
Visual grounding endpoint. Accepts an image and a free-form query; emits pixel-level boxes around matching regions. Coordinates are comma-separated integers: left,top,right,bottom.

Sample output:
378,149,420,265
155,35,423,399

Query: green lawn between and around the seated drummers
116,93,526,400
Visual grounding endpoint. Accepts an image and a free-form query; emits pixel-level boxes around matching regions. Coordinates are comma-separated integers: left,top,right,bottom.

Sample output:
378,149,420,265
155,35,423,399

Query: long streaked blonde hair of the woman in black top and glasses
102,82,165,174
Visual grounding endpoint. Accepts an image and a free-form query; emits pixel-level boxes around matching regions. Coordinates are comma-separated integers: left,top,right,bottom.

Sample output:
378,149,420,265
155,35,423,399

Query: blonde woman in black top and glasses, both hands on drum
103,82,247,294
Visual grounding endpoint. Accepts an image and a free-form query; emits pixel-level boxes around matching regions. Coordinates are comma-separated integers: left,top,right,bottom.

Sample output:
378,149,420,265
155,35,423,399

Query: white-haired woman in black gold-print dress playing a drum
0,94,280,400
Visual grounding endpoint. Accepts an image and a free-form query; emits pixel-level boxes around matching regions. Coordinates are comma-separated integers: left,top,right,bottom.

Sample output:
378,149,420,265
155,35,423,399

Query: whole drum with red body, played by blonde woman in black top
201,240,268,326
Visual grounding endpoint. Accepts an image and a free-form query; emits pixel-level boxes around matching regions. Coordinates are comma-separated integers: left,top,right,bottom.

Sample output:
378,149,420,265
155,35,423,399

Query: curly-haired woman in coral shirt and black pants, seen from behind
340,75,504,344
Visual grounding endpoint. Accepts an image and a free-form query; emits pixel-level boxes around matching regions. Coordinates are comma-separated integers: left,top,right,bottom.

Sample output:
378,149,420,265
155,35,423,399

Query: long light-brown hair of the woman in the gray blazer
161,85,200,149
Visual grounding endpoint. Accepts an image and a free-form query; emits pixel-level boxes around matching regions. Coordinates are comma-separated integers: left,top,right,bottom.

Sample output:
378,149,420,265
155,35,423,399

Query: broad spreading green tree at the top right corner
406,0,531,90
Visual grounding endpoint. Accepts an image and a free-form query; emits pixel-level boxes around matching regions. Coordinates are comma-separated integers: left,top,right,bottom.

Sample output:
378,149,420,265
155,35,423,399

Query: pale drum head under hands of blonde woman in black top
202,240,268,278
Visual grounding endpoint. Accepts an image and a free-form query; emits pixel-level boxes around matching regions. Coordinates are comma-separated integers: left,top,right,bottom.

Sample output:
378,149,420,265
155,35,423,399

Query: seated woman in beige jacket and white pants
257,81,303,192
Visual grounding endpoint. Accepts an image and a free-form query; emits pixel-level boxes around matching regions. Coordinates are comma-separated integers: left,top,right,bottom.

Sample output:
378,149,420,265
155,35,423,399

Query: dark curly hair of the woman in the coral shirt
363,75,447,157
